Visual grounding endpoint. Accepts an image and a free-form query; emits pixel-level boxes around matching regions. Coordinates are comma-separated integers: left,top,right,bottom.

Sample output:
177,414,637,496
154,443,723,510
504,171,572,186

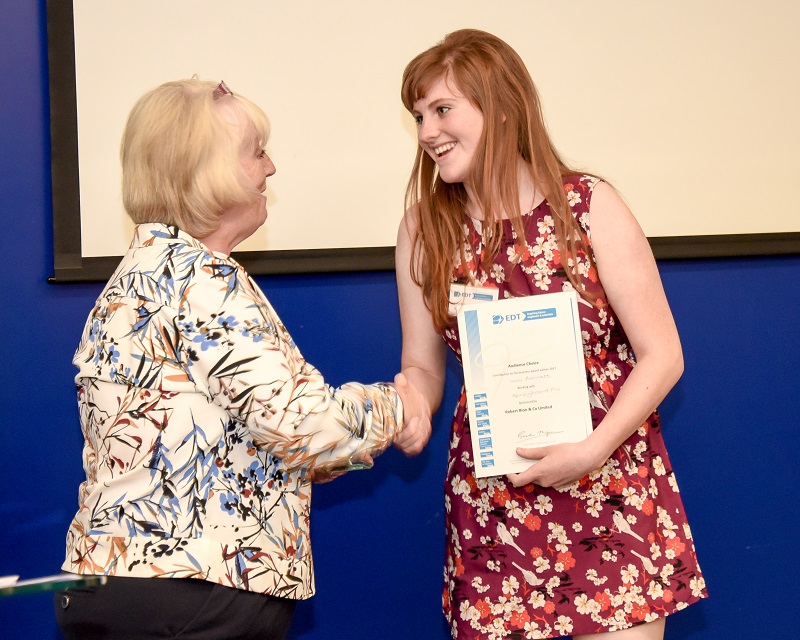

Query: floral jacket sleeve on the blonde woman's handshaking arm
175,265,403,468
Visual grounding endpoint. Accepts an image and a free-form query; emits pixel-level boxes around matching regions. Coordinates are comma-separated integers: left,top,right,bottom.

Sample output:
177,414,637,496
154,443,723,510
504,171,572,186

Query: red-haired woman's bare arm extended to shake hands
395,213,445,456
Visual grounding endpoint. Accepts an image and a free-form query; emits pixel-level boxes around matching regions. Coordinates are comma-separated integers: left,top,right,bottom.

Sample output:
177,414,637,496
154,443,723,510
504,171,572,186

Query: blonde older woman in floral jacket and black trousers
55,79,416,640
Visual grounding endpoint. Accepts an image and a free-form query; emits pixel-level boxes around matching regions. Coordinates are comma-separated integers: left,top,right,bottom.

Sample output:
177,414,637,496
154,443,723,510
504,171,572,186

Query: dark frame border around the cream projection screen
46,0,800,283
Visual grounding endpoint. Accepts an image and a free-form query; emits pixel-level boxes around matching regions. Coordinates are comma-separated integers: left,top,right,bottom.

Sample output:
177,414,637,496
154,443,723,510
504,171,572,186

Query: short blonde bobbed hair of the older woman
120,78,269,238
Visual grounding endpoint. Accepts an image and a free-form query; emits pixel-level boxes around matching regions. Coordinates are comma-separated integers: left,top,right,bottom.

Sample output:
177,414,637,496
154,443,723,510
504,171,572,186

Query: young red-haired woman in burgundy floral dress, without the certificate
395,30,706,640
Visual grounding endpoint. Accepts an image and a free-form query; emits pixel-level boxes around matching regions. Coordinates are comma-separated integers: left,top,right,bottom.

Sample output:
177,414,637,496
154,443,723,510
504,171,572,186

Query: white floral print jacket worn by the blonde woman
63,224,402,599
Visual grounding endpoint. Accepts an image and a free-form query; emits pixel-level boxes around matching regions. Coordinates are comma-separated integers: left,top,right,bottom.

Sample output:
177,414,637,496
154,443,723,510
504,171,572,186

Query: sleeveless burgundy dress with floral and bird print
442,176,707,639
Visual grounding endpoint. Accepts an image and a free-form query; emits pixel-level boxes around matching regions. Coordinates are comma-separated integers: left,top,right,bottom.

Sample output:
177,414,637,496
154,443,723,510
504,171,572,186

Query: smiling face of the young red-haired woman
412,77,483,183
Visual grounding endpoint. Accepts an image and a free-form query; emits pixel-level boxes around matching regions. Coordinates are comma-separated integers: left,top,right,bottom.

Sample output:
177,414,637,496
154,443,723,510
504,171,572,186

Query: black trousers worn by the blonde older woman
53,577,295,640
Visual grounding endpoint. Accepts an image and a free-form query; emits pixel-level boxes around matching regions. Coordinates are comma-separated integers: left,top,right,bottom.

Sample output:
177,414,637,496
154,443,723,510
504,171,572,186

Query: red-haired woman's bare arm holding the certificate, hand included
509,182,683,487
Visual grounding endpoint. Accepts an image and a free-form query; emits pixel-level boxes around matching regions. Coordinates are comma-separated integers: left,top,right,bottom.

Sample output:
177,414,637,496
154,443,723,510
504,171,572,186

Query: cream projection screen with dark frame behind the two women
47,0,800,281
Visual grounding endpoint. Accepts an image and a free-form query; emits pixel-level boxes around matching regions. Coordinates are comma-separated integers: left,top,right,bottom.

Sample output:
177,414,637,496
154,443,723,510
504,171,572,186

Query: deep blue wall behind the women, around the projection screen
0,0,800,640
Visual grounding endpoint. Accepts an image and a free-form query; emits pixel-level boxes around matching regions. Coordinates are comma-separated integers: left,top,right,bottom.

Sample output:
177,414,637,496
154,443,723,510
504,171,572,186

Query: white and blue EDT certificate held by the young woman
458,292,592,478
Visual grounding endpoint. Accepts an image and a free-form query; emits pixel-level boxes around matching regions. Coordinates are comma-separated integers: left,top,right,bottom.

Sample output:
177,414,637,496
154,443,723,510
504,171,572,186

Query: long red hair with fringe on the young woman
401,29,585,330
